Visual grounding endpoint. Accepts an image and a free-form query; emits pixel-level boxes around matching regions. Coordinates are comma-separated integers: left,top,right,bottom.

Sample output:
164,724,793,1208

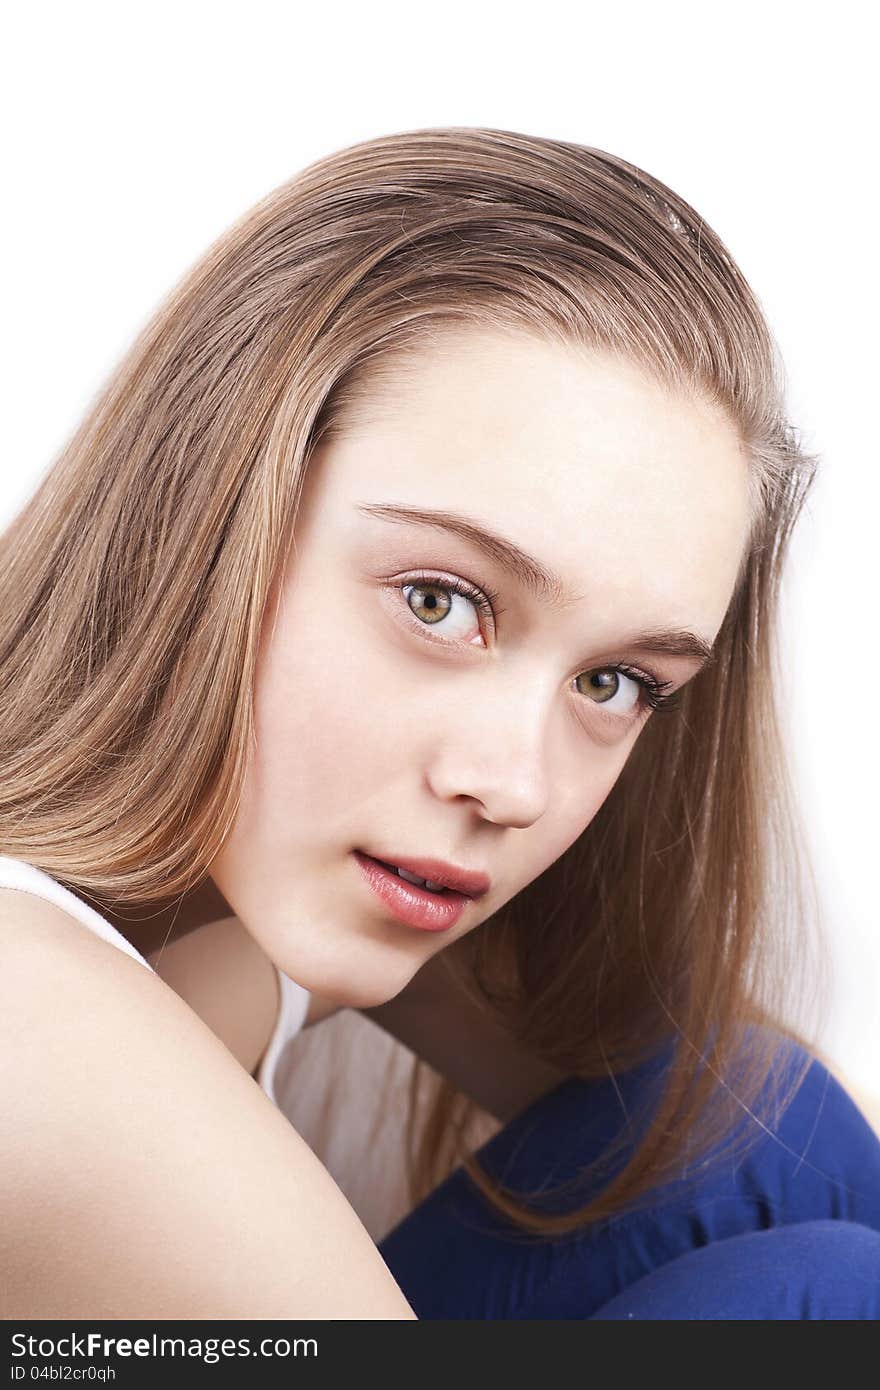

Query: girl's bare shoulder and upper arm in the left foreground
0,891,414,1319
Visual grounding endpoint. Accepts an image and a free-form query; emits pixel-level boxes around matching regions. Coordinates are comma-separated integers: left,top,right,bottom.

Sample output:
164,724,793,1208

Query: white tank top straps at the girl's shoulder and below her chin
0,855,310,1105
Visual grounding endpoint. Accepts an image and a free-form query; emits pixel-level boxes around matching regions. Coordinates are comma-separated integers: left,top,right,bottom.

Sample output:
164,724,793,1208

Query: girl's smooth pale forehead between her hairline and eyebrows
313,335,748,632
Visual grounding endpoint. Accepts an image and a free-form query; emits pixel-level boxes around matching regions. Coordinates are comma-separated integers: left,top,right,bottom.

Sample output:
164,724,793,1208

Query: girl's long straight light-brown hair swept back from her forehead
0,128,819,1237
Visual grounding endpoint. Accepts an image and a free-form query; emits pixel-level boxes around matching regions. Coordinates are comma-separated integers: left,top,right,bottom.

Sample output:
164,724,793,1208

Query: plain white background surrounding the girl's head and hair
0,0,880,1095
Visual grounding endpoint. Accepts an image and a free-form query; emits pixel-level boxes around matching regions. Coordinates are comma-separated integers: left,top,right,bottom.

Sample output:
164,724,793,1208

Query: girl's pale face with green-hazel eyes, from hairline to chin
211,329,748,1008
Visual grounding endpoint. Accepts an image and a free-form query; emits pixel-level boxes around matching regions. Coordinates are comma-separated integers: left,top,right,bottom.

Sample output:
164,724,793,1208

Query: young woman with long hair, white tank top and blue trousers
0,128,880,1319
